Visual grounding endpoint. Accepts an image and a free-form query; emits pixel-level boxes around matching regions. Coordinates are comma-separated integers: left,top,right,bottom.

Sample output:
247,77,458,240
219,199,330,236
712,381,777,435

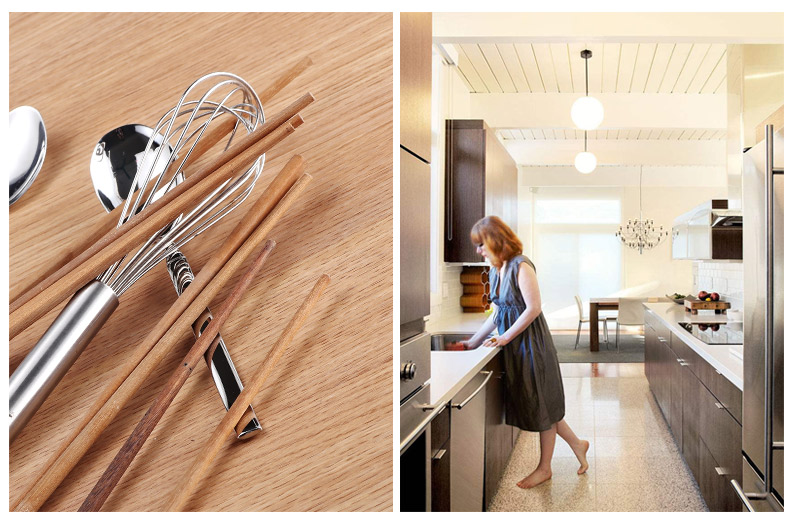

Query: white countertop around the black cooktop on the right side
643,302,743,391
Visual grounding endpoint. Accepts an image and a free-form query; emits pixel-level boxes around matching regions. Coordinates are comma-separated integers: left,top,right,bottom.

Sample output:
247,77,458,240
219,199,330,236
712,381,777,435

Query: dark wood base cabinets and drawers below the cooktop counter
645,306,742,512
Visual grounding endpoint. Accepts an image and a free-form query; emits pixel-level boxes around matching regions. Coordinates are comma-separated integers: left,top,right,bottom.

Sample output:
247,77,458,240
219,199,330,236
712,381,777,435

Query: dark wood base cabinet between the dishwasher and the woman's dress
483,352,513,510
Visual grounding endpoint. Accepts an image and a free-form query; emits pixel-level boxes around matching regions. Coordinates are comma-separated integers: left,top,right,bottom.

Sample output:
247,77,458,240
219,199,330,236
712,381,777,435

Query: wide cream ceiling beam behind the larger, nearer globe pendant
469,93,727,129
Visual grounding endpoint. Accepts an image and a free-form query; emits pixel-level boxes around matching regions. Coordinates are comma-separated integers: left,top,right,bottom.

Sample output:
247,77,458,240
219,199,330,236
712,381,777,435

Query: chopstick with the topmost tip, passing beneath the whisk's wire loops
9,56,313,304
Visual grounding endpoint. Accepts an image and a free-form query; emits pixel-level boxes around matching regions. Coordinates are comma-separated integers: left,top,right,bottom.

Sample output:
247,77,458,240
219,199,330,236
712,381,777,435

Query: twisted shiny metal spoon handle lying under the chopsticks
167,251,261,439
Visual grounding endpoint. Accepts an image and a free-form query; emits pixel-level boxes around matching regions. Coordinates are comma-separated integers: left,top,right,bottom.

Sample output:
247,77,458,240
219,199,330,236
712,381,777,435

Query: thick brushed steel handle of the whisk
8,280,118,441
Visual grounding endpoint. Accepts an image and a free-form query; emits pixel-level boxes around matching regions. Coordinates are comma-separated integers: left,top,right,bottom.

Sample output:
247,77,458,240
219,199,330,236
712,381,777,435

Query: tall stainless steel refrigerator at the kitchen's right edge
731,125,784,512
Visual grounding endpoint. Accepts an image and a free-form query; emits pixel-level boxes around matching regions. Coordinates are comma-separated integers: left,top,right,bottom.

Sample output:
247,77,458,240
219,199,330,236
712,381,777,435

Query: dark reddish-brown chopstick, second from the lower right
79,241,274,512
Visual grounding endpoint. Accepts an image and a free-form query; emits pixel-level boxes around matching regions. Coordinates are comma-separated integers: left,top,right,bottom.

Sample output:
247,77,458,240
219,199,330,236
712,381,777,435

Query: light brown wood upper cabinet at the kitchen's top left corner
400,13,432,163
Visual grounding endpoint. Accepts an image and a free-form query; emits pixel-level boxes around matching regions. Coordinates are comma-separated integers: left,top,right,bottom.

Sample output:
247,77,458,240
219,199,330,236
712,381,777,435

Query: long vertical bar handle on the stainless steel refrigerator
765,125,774,494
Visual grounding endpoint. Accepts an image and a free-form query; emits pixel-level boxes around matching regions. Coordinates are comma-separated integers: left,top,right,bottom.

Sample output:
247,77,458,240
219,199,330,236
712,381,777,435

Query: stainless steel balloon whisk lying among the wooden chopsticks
9,72,264,441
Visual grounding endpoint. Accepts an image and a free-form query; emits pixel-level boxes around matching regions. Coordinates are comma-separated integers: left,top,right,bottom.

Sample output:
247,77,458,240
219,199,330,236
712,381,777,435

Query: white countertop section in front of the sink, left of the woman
431,346,500,404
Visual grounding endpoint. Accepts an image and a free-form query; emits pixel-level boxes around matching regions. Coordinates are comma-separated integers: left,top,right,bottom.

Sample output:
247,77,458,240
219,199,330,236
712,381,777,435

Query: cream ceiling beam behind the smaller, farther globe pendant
504,139,727,167
